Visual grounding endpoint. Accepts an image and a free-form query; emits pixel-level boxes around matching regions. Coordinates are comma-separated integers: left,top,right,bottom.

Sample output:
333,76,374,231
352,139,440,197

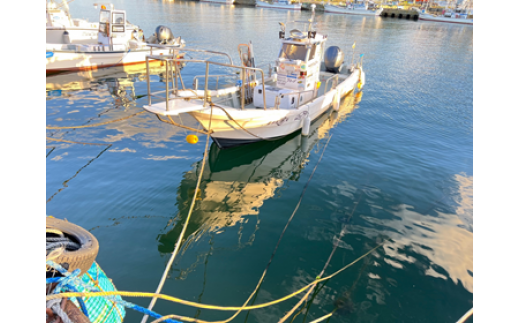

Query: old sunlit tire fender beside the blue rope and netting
46,217,99,274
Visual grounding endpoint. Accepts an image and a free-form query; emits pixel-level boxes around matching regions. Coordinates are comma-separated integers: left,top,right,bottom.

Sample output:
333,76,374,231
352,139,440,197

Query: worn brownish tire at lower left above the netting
45,217,99,274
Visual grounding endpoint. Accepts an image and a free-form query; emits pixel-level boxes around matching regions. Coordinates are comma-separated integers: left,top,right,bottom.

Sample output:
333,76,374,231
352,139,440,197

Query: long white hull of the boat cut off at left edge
46,49,175,75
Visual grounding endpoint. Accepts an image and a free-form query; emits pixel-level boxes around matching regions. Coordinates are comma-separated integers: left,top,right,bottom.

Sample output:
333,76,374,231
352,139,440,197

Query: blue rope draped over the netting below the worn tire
45,260,182,323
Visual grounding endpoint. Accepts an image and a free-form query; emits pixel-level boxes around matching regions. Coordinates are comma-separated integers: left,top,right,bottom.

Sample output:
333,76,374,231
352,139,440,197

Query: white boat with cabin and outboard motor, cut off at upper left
46,5,185,75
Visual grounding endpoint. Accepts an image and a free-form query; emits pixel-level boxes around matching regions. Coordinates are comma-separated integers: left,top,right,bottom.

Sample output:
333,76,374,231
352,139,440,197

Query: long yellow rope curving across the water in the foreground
45,239,389,311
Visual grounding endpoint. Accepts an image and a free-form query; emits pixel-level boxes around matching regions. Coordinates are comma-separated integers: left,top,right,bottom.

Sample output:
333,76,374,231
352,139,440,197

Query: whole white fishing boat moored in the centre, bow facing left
144,5,365,148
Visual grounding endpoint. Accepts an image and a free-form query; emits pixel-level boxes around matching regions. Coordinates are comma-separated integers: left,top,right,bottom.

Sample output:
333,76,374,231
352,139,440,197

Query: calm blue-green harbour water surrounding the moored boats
46,1,473,322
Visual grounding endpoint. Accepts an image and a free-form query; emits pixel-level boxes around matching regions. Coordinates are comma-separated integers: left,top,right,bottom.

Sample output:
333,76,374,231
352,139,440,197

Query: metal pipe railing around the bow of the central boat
146,53,267,111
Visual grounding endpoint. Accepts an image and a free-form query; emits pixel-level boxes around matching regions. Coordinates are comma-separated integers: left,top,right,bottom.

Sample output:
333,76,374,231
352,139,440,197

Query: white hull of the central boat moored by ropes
189,69,364,148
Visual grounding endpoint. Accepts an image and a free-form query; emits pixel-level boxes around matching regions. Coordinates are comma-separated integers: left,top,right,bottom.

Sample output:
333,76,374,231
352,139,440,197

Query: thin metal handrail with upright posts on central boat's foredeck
146,55,267,111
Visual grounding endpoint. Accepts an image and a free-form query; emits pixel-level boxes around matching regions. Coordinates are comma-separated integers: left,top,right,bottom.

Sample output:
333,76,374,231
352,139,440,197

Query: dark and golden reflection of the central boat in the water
159,92,362,267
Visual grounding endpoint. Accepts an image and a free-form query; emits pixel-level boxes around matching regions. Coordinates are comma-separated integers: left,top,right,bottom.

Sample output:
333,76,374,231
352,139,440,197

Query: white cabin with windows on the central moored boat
253,29,327,109
